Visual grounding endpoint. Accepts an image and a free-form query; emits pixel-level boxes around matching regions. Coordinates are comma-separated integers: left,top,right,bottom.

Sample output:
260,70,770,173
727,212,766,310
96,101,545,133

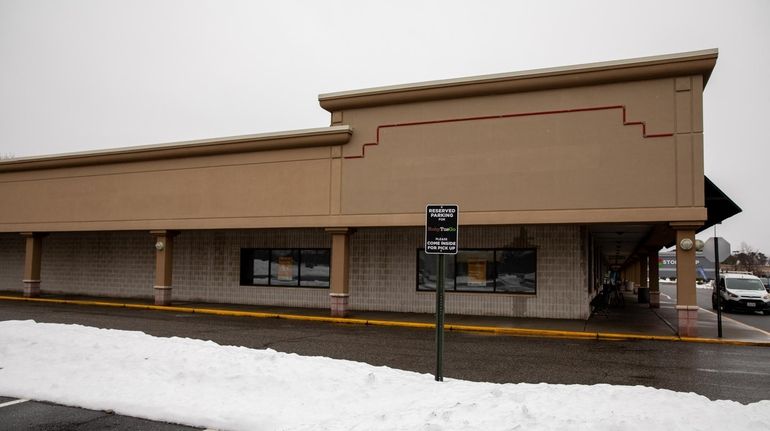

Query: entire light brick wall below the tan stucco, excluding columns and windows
0,225,589,318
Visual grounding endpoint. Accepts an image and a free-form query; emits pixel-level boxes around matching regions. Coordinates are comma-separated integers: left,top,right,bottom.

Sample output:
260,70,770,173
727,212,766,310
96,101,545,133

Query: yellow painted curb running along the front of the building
0,295,770,347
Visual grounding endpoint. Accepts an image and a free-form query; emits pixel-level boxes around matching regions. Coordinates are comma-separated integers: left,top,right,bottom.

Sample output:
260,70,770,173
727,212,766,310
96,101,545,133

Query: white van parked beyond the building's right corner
711,272,770,314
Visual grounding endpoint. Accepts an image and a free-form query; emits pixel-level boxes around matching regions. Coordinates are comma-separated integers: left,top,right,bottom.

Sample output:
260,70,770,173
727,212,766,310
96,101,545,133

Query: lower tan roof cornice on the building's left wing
0,125,353,172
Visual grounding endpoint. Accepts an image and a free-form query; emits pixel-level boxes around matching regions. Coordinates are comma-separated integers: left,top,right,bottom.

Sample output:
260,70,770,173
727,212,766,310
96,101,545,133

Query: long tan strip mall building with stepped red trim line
0,50,738,335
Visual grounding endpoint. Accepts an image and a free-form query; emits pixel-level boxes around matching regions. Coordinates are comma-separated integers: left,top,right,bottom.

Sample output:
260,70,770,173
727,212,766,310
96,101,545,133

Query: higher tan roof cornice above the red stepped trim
318,49,719,112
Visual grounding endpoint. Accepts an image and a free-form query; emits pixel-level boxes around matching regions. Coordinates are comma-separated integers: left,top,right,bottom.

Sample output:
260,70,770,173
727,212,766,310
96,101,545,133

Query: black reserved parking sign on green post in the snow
425,204,460,382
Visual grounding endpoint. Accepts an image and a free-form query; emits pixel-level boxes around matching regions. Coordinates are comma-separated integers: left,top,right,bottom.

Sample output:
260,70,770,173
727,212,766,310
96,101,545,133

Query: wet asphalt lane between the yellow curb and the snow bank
0,301,770,402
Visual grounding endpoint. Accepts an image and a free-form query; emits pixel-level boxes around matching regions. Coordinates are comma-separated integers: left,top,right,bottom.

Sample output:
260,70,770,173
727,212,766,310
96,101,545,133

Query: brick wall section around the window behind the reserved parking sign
350,225,589,319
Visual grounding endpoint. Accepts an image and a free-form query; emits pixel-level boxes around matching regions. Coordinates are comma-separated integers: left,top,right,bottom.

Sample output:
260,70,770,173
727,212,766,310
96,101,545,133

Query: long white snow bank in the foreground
0,321,770,431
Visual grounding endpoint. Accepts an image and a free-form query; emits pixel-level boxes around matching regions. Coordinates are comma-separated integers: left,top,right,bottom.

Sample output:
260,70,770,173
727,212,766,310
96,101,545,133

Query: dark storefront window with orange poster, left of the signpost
241,248,331,288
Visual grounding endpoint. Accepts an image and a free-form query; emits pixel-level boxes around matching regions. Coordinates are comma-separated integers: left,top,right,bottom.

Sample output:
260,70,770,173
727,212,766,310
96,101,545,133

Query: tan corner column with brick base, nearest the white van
671,223,700,337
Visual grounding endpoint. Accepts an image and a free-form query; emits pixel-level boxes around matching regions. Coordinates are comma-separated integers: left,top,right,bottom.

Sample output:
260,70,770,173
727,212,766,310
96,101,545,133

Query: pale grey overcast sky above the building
0,0,770,254
